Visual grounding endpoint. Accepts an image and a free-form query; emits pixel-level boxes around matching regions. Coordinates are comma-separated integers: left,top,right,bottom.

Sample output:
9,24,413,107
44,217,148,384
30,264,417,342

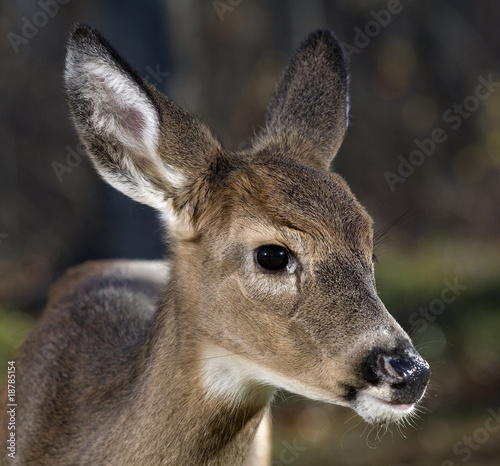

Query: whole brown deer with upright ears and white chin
2,24,430,466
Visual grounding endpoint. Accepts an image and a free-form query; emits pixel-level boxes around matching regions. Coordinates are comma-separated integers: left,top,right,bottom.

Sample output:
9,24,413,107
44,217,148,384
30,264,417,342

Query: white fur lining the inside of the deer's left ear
66,51,187,217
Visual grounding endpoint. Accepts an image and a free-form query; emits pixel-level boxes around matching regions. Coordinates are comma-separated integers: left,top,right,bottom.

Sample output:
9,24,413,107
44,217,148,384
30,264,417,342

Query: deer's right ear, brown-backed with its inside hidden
254,30,348,170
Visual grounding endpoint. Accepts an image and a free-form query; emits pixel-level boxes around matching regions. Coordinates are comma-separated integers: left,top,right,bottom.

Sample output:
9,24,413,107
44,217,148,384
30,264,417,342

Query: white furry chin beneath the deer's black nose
353,390,415,424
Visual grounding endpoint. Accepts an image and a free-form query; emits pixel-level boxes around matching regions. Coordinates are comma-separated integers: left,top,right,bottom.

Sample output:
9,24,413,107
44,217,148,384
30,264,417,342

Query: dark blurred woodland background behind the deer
0,0,500,466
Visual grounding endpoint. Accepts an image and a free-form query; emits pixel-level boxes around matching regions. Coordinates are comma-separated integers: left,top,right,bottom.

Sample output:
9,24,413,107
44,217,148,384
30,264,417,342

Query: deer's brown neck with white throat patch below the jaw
124,286,274,464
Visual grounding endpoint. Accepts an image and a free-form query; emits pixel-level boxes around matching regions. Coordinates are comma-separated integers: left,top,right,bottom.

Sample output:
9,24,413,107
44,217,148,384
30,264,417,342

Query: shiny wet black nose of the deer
363,349,431,404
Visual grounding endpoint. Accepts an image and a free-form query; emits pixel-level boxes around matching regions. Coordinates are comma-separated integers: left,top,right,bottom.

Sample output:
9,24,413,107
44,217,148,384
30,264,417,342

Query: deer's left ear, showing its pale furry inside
65,25,222,214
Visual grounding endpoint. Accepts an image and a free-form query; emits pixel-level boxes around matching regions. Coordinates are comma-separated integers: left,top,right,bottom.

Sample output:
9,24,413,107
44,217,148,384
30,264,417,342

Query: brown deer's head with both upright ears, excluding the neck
65,26,429,430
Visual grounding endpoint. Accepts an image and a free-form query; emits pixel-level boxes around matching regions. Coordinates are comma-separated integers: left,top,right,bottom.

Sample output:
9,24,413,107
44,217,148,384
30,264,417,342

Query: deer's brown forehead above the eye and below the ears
200,161,373,257
